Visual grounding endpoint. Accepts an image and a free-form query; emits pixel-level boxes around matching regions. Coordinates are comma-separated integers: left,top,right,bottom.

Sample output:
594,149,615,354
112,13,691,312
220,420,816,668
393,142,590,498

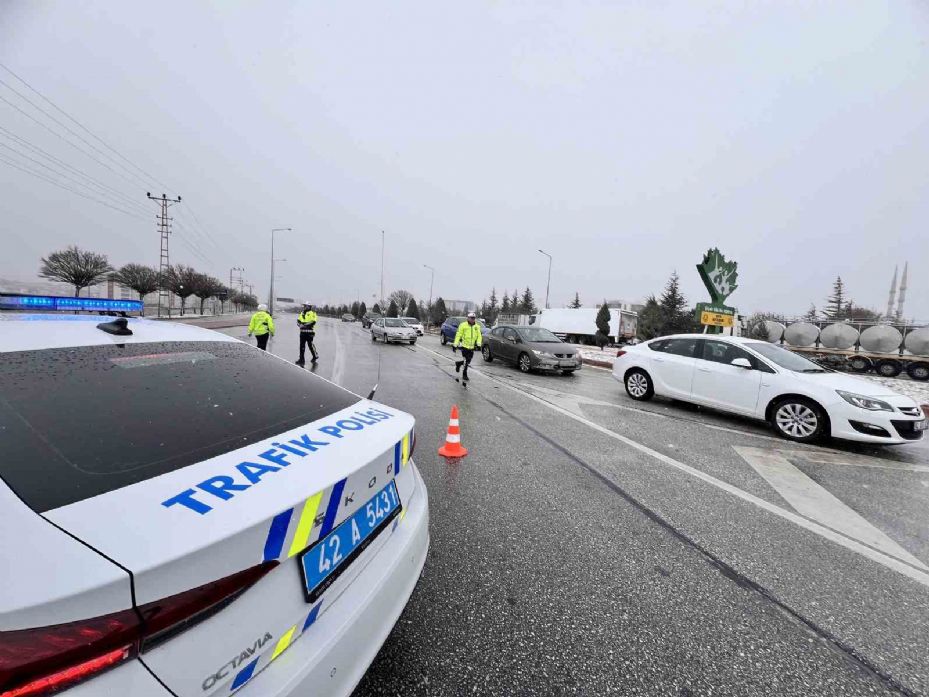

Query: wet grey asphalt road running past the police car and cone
224,315,929,695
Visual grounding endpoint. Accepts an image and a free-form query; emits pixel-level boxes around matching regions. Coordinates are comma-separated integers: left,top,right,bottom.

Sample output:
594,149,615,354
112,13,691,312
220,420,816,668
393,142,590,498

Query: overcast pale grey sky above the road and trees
0,0,929,319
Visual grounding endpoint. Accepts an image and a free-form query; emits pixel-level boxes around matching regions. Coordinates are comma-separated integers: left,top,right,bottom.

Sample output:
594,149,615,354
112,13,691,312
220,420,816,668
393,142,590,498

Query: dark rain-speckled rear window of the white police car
0,341,358,512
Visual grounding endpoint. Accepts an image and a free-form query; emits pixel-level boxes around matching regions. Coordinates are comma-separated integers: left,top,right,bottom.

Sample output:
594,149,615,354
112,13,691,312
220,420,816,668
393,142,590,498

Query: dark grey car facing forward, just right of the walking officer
481,324,581,375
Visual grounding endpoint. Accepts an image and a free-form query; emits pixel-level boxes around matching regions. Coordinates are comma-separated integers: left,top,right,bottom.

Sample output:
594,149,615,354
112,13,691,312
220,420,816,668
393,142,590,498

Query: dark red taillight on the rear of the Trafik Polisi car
0,561,278,697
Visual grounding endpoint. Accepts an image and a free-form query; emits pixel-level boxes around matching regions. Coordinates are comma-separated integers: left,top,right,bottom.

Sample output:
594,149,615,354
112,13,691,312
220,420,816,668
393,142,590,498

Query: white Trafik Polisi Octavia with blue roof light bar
0,296,429,697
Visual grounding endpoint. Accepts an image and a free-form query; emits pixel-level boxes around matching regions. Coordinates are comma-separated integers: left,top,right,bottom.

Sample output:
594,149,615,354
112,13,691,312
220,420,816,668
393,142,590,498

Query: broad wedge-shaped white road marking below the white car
733,445,929,571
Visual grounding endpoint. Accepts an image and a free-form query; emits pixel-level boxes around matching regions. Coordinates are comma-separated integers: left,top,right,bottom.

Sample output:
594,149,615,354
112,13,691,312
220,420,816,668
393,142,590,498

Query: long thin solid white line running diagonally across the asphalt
419,346,929,587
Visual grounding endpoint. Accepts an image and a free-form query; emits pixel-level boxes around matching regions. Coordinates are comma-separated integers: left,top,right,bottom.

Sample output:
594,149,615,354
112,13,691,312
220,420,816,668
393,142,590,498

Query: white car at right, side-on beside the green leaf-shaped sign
613,334,927,444
